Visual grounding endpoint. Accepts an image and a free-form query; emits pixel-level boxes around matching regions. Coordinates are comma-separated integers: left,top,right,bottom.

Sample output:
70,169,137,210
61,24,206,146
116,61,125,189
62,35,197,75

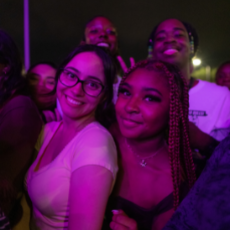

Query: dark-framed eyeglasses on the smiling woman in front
59,69,105,97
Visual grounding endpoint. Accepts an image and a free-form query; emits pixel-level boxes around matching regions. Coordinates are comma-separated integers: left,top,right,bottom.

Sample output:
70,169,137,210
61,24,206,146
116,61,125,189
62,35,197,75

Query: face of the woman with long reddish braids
116,68,170,139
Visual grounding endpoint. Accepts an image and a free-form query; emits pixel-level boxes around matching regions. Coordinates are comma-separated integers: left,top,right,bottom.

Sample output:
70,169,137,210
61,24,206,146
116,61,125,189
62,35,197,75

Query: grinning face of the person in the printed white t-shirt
153,19,191,68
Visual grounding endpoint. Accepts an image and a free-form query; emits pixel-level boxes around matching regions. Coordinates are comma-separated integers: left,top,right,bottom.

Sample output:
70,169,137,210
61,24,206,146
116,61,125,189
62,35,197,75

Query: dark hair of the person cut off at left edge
0,29,25,108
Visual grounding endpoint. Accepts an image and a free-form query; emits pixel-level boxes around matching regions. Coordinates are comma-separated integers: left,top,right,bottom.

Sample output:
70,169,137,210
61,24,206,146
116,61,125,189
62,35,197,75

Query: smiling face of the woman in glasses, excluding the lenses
57,52,105,120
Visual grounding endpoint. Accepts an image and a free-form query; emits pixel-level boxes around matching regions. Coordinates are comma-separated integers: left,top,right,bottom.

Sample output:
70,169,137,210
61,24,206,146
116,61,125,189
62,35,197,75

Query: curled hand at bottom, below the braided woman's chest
110,210,138,230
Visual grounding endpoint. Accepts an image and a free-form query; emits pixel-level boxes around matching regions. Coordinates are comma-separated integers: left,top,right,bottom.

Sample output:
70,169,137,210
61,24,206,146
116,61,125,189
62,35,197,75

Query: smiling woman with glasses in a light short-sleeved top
27,45,117,230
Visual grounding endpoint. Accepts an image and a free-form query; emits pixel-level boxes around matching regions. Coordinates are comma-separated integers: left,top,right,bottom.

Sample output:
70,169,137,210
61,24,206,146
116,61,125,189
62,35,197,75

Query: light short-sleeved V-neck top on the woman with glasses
26,122,118,230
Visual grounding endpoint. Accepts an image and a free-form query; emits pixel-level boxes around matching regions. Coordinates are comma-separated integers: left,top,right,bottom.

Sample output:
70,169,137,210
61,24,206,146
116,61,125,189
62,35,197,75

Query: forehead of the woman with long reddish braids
125,68,169,90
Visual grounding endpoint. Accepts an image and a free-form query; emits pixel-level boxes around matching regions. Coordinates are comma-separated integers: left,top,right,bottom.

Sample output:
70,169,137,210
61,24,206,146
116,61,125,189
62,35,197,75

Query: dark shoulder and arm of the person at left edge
0,100,42,216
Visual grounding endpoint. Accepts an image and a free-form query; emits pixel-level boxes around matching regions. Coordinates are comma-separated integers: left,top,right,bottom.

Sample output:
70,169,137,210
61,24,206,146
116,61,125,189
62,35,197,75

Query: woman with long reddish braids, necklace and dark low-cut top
104,60,195,230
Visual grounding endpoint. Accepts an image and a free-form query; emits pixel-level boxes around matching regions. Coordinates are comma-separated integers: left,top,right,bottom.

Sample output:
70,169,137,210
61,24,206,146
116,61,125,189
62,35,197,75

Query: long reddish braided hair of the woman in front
121,59,196,209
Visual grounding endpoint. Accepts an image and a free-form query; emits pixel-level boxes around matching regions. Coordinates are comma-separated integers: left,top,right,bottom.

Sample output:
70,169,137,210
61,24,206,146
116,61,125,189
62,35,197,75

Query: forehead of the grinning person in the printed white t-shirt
156,19,187,33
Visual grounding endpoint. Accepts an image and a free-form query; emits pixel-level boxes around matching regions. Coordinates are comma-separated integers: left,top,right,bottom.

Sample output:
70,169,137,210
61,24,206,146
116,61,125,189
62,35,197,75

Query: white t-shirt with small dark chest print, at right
189,80,230,140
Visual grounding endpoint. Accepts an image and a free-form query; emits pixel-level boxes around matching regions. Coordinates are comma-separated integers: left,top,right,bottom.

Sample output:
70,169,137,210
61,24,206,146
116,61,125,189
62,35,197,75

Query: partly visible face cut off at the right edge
216,63,230,89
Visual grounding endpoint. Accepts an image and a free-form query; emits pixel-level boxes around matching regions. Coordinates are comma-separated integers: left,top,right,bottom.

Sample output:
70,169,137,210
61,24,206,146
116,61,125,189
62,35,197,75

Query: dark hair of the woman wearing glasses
56,45,116,127
